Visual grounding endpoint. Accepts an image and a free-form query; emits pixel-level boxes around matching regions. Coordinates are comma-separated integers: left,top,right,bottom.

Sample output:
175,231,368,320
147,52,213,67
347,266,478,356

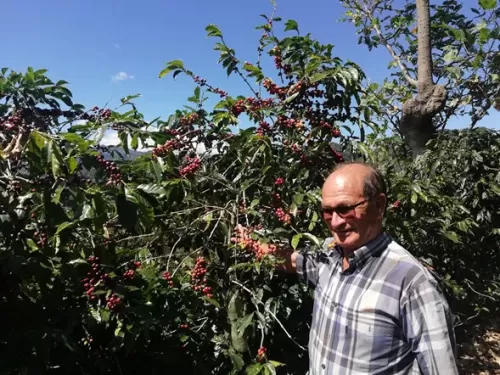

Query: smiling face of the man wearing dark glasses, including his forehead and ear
322,169,386,252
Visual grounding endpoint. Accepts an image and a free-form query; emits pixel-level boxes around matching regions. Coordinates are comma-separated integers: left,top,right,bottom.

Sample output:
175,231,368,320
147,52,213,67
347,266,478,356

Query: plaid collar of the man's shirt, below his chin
328,232,392,273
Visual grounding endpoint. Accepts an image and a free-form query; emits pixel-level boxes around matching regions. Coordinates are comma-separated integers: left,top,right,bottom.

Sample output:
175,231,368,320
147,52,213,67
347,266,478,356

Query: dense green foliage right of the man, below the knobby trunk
360,128,500,324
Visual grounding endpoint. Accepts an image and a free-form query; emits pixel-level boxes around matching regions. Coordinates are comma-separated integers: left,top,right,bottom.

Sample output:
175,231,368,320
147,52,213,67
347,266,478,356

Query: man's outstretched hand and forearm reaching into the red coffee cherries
231,224,297,273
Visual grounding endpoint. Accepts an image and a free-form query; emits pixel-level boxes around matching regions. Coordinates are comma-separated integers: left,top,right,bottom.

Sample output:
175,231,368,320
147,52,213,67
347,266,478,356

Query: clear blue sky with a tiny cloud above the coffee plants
0,0,500,147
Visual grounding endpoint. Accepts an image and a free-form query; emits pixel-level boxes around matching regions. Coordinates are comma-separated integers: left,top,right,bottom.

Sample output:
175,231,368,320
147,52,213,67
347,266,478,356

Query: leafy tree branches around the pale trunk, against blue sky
341,0,500,132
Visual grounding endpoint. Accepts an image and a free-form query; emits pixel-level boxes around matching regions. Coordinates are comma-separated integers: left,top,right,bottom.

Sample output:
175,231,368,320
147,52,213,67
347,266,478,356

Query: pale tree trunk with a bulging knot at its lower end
400,0,447,157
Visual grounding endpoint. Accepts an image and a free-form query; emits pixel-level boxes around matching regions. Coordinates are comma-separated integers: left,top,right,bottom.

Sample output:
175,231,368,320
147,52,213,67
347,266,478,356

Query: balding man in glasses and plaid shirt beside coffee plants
238,163,458,375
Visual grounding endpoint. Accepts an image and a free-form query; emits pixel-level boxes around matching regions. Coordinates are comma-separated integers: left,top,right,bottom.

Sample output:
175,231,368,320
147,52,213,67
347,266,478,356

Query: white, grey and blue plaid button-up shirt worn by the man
297,233,458,375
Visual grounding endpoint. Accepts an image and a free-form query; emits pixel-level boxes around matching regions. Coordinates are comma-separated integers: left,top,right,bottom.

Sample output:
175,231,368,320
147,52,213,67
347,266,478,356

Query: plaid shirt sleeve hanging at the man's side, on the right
401,280,458,375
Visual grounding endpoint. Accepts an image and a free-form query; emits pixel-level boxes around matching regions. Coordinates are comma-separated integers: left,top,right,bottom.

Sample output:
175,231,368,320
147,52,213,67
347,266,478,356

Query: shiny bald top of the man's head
323,162,387,203
